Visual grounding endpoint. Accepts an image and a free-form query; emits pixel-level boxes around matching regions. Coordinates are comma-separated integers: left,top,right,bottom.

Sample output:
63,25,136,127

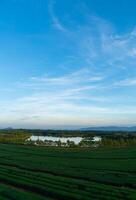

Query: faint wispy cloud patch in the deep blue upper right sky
77,16,136,73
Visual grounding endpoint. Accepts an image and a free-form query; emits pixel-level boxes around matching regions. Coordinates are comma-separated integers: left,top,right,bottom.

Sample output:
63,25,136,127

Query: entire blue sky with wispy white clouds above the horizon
0,0,136,129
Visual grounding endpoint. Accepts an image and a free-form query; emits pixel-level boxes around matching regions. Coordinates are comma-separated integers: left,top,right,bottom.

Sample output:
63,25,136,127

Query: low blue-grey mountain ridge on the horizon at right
81,126,136,132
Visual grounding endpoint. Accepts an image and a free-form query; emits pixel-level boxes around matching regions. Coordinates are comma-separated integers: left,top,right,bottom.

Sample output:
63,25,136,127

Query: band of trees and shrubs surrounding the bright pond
0,129,136,148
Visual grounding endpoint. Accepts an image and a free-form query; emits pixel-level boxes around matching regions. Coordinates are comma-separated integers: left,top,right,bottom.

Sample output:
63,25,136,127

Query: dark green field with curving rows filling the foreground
0,144,136,200
